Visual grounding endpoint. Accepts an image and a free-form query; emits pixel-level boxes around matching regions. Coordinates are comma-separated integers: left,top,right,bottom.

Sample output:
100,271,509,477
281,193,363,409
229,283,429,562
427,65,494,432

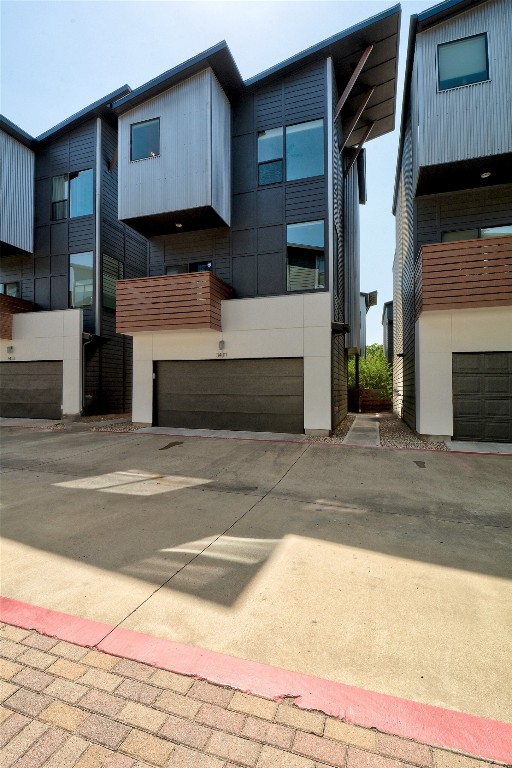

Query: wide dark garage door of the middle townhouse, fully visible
155,358,304,433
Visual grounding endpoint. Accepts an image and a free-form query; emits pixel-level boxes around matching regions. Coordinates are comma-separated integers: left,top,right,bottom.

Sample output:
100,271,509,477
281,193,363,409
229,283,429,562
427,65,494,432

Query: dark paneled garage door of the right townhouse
453,352,512,443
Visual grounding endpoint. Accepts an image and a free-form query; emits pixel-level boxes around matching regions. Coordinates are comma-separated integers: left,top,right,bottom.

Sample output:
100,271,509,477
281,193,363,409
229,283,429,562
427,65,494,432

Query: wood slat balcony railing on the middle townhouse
116,272,233,334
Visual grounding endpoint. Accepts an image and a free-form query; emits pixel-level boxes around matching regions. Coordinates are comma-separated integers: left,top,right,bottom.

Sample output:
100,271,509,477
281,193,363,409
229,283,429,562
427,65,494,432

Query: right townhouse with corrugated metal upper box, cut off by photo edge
393,0,512,442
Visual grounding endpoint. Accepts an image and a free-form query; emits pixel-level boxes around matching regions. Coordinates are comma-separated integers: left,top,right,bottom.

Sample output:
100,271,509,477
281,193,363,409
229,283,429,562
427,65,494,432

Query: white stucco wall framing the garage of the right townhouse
416,307,512,436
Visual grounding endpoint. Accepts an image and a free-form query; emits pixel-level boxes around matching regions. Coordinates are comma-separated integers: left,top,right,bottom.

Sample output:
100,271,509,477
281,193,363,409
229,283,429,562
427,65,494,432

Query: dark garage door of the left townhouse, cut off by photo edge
0,360,62,419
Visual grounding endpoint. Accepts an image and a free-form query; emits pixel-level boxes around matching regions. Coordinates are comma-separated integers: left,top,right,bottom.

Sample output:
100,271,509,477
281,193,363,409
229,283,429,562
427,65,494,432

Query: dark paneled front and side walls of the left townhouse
0,119,147,413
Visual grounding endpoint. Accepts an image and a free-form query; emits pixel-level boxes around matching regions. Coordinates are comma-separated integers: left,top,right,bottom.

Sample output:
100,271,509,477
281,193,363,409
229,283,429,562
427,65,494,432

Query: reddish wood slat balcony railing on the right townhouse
415,235,512,317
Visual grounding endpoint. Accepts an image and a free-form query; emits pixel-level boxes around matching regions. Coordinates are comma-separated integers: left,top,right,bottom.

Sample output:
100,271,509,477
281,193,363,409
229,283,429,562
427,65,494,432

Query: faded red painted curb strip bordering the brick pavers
0,597,512,762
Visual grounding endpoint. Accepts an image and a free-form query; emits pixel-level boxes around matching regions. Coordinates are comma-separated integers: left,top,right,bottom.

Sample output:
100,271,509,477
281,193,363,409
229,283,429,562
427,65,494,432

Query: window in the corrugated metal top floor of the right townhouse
437,33,489,91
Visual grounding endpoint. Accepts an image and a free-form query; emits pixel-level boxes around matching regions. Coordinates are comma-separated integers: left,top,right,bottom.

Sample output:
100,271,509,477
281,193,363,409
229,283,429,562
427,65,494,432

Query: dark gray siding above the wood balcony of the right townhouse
416,184,512,250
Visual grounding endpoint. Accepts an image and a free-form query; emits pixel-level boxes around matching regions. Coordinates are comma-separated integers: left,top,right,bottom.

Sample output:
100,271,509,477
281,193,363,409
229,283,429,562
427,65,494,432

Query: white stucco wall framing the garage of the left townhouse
0,309,82,415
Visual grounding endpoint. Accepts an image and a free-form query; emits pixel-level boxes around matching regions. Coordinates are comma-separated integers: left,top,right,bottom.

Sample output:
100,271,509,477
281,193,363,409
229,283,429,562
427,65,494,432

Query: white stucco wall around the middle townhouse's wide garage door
133,293,331,431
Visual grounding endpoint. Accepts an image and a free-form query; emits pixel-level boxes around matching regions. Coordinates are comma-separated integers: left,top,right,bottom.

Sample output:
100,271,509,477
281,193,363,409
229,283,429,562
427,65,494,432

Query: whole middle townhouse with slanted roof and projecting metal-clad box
113,6,400,434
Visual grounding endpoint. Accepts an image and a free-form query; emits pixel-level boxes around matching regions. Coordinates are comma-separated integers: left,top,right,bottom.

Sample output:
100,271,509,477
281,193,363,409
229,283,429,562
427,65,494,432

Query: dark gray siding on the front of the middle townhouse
150,62,328,297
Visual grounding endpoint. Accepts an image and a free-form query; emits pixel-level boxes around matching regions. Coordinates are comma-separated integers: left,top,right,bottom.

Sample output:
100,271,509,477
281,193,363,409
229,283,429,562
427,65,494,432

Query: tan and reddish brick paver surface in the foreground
0,623,504,768
